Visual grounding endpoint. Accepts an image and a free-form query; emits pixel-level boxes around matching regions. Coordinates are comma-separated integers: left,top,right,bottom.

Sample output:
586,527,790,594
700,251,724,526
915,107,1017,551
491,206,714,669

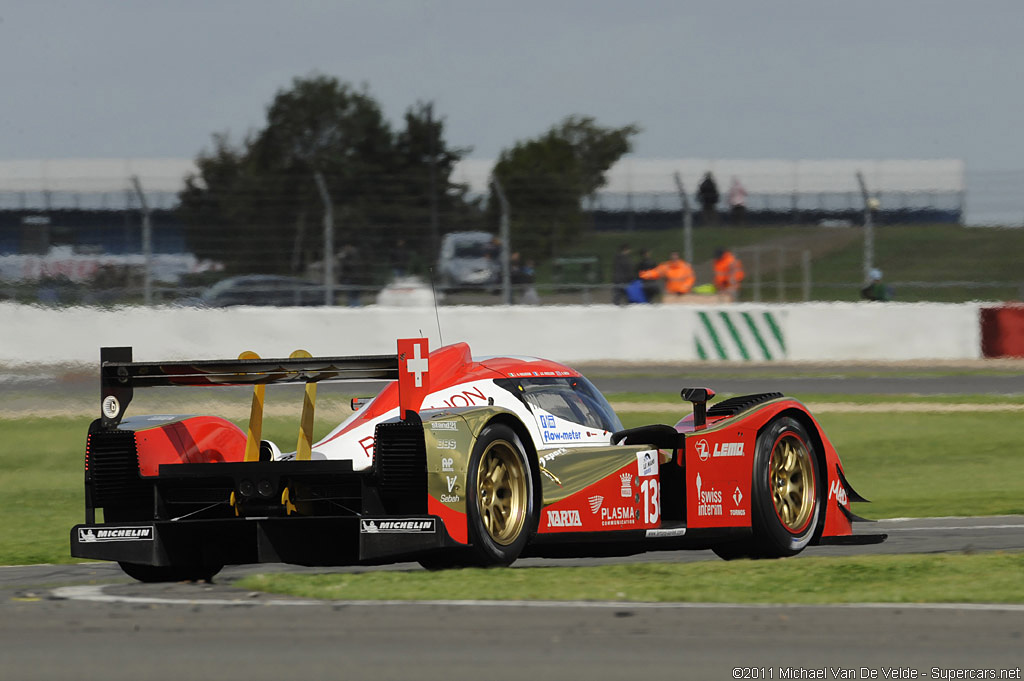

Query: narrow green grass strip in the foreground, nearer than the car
236,553,1024,603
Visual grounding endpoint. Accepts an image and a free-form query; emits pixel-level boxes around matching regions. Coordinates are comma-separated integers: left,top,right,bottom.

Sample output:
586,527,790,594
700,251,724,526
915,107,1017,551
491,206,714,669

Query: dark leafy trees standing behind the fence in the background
178,75,639,273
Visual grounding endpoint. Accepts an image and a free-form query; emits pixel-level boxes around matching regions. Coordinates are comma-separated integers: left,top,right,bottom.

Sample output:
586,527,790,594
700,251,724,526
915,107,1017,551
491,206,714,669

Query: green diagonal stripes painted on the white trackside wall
693,309,787,361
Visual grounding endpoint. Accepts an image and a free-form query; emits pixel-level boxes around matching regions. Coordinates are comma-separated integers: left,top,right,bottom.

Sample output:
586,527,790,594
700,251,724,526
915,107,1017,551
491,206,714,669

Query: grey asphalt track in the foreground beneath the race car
0,516,1024,681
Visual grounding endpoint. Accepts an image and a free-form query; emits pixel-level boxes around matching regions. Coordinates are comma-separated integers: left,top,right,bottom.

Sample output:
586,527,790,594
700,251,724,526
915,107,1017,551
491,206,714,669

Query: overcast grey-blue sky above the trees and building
0,0,1024,170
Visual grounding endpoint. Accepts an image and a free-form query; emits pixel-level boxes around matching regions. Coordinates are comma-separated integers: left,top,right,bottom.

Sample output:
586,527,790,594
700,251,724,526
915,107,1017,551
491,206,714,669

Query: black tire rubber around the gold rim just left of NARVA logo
466,424,537,565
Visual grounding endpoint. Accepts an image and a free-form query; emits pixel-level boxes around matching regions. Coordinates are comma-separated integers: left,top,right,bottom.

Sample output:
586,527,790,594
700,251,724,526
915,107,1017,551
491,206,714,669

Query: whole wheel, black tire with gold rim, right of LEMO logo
713,417,822,560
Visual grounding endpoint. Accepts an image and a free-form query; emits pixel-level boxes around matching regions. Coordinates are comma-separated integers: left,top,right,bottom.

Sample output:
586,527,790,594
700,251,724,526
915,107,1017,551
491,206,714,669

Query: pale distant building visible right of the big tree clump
453,158,967,229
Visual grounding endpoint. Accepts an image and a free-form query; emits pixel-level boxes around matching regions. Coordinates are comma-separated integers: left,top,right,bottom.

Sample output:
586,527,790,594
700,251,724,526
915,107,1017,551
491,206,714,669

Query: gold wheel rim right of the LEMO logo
768,434,815,534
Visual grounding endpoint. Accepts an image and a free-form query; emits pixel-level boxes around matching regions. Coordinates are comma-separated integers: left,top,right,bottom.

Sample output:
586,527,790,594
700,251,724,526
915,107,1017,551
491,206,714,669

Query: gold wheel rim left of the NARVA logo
476,440,528,546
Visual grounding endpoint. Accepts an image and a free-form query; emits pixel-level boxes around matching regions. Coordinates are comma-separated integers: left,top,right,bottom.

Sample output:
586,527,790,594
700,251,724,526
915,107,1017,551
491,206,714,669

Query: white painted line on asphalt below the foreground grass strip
51,585,1024,612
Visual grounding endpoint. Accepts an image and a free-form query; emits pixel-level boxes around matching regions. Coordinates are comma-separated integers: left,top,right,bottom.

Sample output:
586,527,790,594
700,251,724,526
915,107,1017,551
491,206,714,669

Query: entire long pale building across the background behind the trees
0,158,966,260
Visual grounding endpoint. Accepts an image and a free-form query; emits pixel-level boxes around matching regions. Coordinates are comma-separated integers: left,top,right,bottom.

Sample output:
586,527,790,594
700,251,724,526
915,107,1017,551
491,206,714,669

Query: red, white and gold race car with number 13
71,338,885,581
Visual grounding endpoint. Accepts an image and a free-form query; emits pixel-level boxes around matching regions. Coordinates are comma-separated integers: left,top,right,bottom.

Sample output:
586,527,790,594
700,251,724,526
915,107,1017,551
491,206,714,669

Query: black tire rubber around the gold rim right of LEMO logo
751,417,822,556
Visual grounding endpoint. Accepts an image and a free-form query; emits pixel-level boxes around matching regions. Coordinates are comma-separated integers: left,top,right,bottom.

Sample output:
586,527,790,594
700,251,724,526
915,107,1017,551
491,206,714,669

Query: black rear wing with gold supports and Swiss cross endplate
99,338,430,461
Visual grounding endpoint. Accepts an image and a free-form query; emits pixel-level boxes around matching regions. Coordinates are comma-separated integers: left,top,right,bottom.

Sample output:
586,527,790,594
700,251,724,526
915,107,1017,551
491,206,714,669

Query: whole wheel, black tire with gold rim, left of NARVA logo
466,423,538,565
